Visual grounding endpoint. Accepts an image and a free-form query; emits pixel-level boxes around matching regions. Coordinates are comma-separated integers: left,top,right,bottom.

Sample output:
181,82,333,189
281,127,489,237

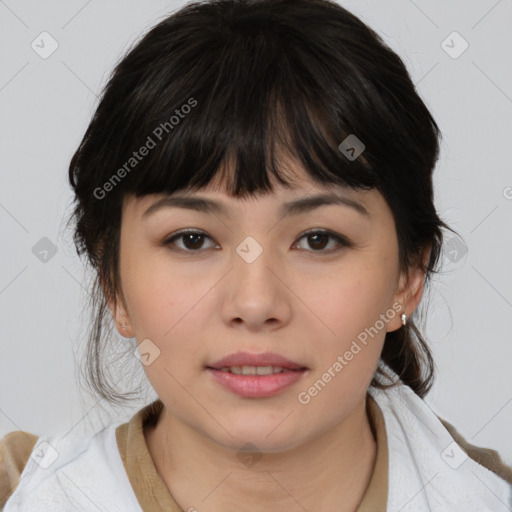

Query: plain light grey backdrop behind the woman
0,0,512,464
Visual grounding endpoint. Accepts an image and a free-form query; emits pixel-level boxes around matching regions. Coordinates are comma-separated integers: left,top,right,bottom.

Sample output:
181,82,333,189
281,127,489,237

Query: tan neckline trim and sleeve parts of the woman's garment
0,394,512,512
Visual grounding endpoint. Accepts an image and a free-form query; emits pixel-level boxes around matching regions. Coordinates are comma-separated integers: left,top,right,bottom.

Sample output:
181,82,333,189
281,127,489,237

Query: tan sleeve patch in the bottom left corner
0,430,38,510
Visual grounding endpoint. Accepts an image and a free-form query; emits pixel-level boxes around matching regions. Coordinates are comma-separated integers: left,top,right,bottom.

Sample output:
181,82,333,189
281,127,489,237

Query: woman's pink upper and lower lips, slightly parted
206,352,308,398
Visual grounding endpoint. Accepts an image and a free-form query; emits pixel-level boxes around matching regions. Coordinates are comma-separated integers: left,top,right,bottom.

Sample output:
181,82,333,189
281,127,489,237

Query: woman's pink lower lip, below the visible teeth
207,368,306,398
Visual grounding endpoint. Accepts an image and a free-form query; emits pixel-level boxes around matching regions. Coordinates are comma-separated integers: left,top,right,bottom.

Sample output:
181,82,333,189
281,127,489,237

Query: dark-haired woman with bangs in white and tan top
2,0,512,512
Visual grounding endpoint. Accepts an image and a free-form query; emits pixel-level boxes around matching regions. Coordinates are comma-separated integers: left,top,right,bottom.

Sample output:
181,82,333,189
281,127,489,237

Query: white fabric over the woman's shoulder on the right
368,363,512,512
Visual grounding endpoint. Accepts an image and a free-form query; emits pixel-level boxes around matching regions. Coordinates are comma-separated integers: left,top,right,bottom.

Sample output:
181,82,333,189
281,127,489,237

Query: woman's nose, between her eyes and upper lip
222,237,292,332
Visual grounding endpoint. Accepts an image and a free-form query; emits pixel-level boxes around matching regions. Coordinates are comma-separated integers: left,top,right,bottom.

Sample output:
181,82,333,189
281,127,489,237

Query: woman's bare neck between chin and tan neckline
145,399,377,512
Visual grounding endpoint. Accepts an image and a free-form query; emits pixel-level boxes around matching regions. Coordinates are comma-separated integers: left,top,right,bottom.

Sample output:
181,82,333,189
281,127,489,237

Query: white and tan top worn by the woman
0,368,512,512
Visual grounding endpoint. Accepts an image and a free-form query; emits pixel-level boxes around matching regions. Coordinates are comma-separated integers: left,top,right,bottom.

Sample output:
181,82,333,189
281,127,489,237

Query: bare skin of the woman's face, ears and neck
110,167,428,512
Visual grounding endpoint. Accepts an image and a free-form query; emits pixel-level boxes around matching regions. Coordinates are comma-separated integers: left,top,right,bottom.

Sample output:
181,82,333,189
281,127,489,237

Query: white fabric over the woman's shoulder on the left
0,424,142,512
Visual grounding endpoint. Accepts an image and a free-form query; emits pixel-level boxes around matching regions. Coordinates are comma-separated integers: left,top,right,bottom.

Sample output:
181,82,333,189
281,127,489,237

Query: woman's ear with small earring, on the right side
387,245,432,332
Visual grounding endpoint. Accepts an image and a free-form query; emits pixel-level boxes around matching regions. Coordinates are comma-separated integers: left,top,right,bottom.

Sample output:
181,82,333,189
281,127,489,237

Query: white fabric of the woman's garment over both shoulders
4,367,512,512
